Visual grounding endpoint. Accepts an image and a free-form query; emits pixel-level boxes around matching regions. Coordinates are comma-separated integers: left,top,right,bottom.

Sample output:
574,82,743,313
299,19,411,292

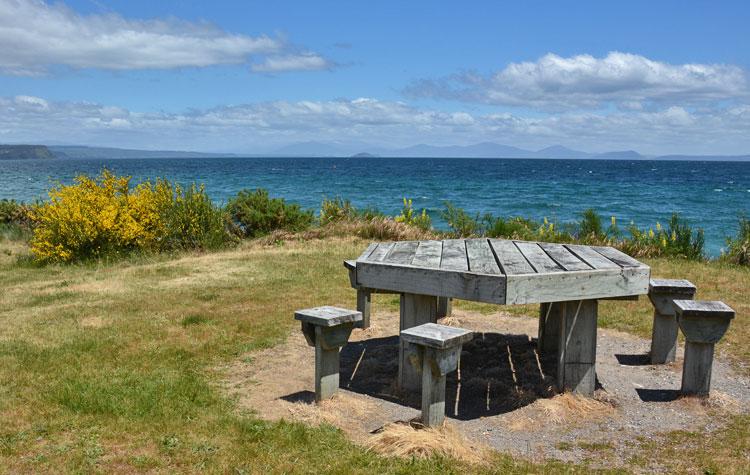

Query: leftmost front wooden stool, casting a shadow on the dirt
294,307,362,402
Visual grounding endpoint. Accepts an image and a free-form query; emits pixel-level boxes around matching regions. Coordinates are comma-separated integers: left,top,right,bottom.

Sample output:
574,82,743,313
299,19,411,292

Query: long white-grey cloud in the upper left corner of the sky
0,0,325,75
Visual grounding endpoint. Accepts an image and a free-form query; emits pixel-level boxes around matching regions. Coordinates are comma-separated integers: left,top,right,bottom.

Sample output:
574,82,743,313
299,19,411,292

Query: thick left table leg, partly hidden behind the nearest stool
398,293,437,391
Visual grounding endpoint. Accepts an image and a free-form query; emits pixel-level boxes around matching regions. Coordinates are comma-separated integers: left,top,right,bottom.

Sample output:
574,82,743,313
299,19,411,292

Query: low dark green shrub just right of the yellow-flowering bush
227,188,313,238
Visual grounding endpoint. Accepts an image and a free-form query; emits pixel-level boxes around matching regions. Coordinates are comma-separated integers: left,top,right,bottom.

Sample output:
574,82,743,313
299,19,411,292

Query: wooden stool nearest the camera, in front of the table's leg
401,323,473,426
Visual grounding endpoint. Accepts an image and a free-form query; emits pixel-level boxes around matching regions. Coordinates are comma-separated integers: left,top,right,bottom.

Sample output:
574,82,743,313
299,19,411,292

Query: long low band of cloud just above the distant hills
0,96,750,154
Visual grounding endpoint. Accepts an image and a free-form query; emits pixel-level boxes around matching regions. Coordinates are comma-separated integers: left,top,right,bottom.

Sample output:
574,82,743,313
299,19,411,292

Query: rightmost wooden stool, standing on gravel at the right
673,300,734,396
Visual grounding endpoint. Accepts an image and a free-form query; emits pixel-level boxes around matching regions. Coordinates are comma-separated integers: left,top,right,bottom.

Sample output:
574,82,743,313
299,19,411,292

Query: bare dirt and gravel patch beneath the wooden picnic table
227,310,750,464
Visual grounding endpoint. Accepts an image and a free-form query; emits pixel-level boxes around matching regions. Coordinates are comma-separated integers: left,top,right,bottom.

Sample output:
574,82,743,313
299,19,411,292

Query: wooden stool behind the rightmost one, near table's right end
648,279,695,364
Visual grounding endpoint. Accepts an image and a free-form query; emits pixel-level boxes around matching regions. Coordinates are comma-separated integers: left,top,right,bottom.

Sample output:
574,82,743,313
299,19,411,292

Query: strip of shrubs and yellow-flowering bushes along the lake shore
0,170,750,265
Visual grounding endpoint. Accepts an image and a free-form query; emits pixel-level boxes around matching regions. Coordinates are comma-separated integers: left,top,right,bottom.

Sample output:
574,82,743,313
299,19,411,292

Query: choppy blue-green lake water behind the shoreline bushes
0,157,750,255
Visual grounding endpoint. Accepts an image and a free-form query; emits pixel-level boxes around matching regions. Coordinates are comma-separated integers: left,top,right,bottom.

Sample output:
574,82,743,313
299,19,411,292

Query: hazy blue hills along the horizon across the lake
0,142,750,161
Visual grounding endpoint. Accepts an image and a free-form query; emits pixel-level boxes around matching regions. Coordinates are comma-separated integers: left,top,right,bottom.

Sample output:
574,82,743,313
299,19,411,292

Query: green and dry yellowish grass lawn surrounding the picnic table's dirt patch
0,239,750,473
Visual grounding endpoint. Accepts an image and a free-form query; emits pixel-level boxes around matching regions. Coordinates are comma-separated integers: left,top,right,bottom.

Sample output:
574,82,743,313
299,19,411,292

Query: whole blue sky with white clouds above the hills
0,0,750,154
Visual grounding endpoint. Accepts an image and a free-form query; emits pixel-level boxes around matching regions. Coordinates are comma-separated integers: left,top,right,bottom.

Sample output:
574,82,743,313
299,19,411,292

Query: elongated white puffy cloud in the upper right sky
406,52,748,110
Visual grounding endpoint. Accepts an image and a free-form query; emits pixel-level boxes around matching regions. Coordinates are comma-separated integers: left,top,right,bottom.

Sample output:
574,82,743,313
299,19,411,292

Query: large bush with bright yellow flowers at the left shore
31,170,231,262
